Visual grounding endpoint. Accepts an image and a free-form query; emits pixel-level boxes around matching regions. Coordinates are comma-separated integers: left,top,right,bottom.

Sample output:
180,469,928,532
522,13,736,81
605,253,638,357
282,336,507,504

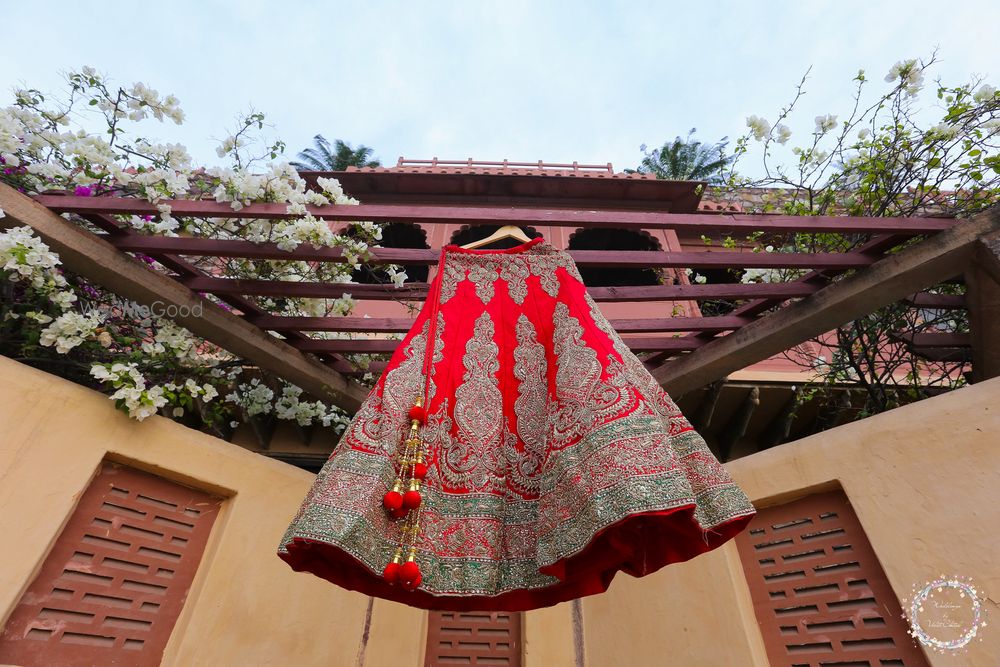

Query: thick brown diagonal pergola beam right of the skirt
653,210,1000,396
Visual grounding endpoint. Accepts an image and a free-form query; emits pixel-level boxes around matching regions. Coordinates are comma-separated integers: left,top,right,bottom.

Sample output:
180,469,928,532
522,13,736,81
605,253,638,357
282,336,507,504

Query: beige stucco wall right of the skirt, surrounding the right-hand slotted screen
583,378,1000,667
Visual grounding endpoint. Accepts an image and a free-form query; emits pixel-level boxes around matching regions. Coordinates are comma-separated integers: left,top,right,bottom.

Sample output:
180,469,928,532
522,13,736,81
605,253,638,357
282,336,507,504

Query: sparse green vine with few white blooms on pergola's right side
702,54,1000,415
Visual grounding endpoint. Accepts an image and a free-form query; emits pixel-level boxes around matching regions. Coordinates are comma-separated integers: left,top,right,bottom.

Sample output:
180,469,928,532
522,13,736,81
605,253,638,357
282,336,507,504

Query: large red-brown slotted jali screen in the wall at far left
0,462,222,667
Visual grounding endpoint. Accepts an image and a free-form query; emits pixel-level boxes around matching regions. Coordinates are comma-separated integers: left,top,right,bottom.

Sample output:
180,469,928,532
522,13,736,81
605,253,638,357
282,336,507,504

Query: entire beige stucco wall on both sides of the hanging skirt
0,357,1000,667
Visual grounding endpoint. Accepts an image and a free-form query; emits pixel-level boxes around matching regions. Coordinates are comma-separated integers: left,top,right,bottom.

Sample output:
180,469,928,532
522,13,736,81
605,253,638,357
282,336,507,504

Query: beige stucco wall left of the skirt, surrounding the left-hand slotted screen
0,357,423,667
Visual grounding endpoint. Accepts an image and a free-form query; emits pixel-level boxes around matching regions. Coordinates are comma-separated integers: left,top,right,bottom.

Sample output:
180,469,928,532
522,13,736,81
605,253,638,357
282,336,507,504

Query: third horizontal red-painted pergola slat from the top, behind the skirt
178,277,819,302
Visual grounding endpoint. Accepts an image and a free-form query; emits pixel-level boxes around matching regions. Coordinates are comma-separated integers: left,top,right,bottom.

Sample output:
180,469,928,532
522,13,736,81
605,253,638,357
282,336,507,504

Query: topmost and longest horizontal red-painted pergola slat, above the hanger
35,195,956,235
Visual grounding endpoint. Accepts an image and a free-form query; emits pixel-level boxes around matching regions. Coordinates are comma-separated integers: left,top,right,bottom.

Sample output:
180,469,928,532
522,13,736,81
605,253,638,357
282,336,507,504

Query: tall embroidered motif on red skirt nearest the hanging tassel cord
441,312,503,490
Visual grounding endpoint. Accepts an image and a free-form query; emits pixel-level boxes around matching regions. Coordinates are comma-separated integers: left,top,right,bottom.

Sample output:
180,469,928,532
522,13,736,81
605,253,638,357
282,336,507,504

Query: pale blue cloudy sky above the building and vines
0,0,1000,171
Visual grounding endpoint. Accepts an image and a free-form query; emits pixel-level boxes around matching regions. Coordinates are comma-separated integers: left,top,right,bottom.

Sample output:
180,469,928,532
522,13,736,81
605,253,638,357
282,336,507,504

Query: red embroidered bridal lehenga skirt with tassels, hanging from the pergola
278,238,755,611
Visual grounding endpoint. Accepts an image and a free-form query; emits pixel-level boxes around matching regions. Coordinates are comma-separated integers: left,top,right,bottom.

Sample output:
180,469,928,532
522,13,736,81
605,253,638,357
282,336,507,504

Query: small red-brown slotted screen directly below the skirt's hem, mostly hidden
424,611,521,667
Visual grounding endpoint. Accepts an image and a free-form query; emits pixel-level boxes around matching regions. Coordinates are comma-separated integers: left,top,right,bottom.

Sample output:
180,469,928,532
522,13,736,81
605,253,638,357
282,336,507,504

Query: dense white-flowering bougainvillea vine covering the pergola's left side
0,67,406,434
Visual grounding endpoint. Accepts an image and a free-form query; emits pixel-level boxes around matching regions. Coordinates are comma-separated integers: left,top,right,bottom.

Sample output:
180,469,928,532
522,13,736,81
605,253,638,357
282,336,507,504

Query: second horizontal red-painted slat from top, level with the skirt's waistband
101,234,875,270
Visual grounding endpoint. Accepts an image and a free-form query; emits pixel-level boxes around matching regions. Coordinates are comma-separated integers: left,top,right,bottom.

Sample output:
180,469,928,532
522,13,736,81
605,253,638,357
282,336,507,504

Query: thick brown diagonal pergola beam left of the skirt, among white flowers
0,184,368,413
